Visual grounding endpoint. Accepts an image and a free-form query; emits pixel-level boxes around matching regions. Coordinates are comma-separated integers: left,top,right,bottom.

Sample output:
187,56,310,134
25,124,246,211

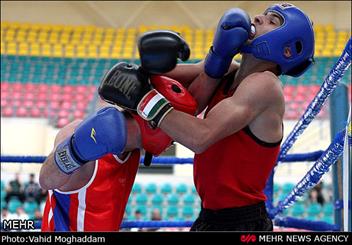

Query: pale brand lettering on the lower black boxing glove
104,72,137,99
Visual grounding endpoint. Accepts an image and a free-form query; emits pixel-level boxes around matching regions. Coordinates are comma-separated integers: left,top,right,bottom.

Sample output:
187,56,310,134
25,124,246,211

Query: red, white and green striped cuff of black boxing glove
137,89,169,120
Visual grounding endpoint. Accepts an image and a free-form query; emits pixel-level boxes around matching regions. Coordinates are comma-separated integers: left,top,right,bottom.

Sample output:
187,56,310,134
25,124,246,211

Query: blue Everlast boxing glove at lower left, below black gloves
54,107,127,174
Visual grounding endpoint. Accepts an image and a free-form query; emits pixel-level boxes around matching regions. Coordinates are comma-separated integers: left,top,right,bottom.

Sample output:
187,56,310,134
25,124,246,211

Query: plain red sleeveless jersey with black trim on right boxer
193,72,280,210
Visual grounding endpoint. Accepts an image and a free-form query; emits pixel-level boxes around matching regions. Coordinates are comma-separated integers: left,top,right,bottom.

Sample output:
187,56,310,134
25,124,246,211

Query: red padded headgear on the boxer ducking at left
133,75,197,166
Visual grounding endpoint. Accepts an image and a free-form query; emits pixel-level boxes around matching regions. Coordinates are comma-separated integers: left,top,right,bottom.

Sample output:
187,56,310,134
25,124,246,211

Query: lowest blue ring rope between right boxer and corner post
274,217,340,231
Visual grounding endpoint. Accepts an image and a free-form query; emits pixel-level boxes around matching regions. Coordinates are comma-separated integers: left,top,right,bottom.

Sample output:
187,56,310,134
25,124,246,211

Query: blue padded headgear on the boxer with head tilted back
241,3,314,77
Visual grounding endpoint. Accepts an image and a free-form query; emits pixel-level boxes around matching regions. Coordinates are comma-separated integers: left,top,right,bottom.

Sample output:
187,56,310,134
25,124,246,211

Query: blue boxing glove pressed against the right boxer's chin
204,8,251,78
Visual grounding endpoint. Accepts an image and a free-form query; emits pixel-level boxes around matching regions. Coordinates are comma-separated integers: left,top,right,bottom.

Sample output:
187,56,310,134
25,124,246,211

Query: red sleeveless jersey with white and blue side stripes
42,150,140,231
